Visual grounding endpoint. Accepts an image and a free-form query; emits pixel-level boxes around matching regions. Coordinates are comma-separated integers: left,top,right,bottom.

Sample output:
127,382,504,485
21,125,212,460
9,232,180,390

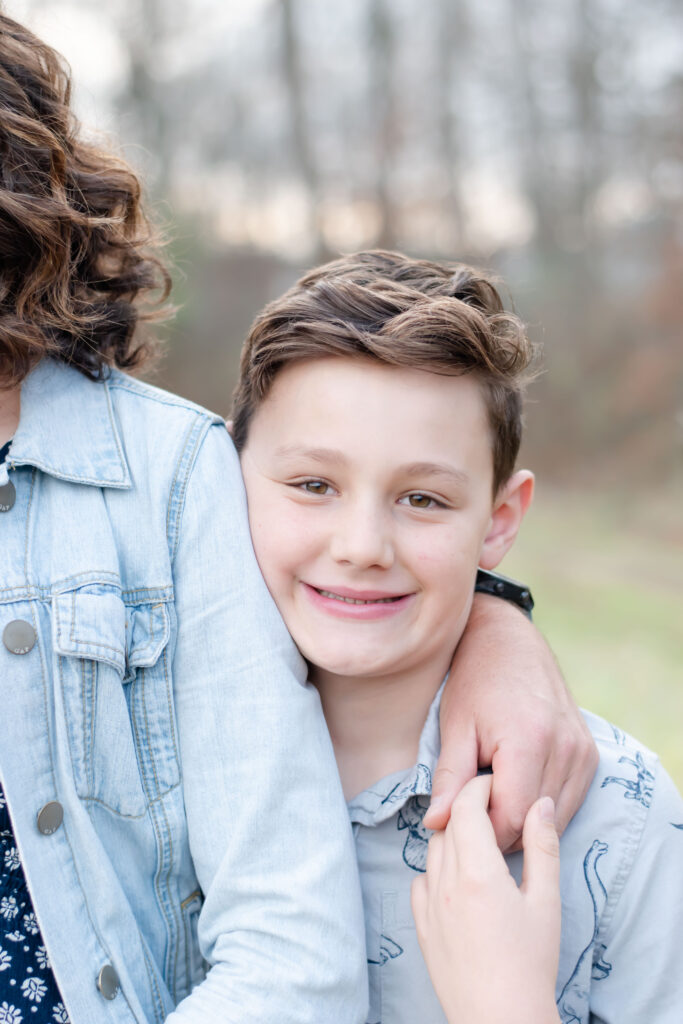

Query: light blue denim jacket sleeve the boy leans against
167,425,367,1024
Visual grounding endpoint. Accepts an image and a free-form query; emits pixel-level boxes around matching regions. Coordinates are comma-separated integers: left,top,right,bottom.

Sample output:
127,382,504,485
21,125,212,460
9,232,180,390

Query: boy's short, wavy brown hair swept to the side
232,250,532,494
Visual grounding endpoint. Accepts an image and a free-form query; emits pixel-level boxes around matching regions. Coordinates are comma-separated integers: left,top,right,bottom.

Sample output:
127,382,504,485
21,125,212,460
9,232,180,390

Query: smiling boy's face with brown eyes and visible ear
242,357,531,676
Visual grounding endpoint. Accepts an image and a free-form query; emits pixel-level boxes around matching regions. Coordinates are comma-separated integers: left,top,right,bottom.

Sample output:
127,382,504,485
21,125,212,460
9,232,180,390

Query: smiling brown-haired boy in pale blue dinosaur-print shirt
233,252,683,1024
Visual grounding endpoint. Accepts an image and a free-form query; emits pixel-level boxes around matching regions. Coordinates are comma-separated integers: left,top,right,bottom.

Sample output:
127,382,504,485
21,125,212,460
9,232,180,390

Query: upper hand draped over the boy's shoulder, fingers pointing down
425,594,598,850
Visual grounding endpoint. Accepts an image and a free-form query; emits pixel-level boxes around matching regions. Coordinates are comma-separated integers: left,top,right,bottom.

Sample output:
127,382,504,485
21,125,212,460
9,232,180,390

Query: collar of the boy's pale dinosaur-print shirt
348,680,445,825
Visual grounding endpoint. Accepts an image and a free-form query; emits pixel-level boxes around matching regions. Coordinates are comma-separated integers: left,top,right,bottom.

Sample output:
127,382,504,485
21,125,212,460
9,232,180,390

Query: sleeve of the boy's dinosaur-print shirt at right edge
590,767,683,1024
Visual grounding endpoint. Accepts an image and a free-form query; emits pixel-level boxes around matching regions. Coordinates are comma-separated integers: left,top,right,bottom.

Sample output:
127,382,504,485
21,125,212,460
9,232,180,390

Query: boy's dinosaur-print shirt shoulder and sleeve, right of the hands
548,712,683,1024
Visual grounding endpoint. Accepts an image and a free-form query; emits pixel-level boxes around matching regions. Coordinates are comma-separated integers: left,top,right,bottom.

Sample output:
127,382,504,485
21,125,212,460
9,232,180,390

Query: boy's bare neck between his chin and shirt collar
309,651,453,800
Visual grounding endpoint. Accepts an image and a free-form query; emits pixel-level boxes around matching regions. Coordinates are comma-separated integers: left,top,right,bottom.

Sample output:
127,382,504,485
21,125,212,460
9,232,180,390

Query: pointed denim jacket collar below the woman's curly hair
7,358,131,488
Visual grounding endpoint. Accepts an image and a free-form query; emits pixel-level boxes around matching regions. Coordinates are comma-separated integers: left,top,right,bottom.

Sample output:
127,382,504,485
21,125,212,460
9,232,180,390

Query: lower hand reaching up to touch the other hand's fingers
412,775,561,1024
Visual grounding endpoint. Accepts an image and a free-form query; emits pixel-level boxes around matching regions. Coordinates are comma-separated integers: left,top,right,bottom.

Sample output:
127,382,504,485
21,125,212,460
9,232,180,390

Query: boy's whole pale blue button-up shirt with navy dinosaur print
348,691,683,1024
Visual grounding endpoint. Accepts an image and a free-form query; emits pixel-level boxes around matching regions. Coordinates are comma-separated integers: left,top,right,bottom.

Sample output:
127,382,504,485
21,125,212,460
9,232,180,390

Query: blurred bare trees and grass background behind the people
5,0,683,784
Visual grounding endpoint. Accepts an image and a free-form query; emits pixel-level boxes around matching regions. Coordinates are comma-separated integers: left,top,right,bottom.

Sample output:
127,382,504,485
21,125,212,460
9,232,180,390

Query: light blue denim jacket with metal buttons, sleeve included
0,360,367,1024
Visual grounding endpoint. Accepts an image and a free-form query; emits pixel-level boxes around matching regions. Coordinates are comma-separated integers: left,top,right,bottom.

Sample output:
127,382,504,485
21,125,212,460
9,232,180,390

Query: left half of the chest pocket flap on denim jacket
53,591,126,675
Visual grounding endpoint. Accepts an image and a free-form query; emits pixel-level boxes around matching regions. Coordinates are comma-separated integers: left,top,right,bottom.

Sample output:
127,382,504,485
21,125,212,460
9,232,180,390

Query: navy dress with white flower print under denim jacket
0,444,69,1024
